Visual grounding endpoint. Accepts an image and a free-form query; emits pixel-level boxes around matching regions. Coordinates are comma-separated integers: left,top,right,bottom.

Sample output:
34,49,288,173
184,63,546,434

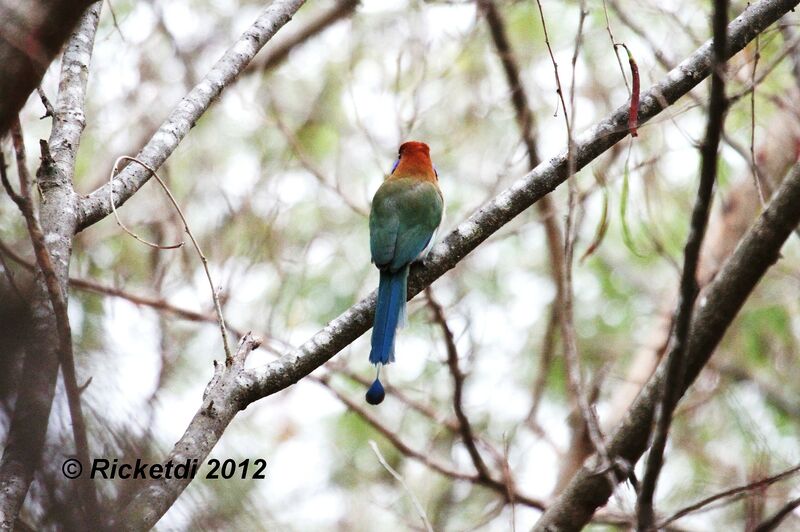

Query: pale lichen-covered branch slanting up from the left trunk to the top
77,0,305,231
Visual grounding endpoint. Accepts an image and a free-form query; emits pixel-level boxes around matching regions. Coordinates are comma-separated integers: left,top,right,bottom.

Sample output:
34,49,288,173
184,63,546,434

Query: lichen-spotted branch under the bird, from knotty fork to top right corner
243,0,798,400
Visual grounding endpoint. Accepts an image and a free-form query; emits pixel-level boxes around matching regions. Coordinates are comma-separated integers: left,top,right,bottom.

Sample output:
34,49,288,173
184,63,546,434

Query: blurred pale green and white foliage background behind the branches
0,0,800,531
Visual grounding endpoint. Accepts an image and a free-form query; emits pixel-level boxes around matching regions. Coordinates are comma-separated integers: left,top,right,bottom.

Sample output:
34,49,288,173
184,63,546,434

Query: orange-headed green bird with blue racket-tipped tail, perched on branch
366,141,444,405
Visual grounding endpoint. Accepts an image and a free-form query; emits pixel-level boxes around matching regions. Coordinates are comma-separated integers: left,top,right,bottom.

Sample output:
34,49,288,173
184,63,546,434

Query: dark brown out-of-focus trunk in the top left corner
0,0,96,137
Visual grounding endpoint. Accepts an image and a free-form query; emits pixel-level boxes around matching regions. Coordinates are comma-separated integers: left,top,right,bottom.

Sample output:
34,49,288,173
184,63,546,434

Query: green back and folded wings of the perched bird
369,177,444,271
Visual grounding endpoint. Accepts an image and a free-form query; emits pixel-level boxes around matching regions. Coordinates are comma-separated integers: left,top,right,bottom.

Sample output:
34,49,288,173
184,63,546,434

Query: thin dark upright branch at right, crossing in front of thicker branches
636,0,728,531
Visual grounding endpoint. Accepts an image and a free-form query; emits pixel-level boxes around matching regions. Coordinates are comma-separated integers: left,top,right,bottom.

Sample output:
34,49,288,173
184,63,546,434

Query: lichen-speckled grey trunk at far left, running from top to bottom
0,3,101,529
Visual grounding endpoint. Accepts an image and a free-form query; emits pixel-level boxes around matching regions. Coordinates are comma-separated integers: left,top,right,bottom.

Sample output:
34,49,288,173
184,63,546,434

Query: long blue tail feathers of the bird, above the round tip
369,266,408,364
